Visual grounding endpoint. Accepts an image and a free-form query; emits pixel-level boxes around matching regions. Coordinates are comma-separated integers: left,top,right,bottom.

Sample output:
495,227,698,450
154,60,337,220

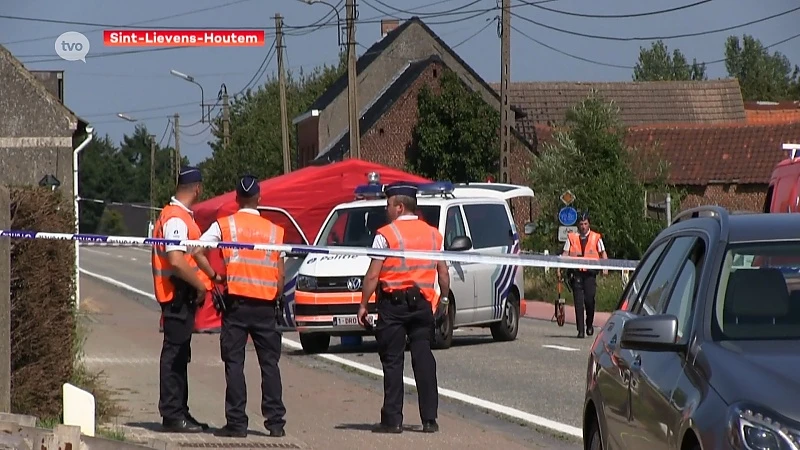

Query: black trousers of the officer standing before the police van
375,299,439,426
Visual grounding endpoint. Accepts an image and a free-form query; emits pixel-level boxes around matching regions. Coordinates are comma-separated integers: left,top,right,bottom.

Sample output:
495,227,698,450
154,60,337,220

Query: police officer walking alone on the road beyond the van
559,212,608,338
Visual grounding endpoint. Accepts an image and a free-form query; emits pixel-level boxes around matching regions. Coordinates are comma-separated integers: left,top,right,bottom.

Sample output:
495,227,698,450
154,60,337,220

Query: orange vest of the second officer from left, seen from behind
217,211,284,300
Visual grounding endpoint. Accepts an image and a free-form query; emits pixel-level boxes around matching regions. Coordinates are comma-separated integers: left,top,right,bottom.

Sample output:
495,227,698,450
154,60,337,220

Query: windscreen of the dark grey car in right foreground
711,241,800,340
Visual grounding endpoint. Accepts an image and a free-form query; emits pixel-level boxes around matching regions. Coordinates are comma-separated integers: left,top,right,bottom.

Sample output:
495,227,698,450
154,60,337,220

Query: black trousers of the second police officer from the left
220,296,286,430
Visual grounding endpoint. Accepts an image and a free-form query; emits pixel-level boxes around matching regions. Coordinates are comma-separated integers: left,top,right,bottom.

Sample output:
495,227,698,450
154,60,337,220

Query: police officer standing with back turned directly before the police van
358,183,450,433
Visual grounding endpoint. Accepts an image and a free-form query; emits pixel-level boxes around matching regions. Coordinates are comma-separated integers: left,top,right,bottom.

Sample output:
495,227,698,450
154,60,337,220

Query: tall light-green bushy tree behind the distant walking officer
531,93,679,259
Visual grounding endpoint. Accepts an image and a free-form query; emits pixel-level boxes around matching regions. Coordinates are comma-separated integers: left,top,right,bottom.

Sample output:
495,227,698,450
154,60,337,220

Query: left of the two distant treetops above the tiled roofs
633,40,707,81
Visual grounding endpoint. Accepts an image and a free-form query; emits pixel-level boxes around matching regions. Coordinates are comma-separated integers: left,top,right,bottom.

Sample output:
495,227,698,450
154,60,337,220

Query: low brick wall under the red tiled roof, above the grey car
681,184,767,212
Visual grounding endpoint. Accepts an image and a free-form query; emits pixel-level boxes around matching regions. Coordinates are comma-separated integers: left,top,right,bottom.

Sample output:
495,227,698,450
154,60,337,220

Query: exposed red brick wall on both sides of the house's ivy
361,63,533,233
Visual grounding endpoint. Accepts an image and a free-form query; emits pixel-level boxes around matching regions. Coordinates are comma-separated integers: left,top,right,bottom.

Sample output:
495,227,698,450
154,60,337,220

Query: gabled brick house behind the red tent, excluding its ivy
292,17,536,227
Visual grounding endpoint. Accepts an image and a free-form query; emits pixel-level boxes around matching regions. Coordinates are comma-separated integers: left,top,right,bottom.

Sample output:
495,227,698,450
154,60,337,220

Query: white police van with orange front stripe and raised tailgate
292,173,534,353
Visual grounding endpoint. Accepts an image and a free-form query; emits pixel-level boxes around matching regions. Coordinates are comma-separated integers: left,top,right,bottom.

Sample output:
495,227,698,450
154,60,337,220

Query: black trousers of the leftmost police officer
158,302,196,420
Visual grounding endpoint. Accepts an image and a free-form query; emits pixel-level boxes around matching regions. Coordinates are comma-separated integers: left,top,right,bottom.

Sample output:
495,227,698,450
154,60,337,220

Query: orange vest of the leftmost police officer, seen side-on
150,205,213,303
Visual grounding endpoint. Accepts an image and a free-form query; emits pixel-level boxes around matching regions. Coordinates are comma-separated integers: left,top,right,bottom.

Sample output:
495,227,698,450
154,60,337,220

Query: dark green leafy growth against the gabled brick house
407,70,500,182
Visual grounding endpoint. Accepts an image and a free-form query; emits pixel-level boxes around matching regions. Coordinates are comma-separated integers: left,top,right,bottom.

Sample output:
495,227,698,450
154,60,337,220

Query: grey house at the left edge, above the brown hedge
0,45,87,198
